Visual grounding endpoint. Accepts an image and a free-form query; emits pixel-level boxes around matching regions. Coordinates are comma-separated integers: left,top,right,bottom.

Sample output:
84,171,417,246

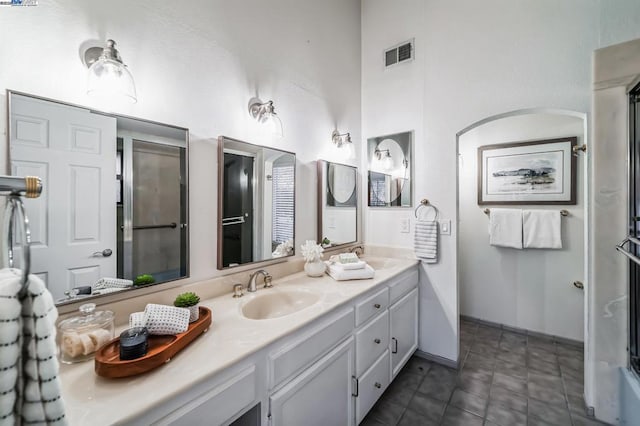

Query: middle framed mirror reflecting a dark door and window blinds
218,136,296,269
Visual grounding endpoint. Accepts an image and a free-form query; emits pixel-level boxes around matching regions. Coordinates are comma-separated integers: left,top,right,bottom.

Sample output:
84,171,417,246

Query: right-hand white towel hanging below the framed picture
524,210,562,249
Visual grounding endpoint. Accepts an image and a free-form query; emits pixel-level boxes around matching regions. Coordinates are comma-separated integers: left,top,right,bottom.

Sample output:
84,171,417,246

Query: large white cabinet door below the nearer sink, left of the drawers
269,337,354,426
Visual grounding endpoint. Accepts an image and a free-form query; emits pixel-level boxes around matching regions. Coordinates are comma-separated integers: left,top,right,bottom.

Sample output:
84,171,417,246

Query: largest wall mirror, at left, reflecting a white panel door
8,91,189,303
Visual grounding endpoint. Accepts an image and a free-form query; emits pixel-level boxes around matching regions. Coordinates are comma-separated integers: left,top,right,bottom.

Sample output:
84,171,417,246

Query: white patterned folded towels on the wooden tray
129,303,191,335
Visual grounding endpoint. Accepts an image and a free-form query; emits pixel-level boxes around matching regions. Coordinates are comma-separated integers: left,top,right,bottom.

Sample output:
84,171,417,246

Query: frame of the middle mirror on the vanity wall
216,135,298,271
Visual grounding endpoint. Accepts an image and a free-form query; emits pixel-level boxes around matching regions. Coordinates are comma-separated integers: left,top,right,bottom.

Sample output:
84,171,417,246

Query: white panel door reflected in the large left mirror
10,94,117,299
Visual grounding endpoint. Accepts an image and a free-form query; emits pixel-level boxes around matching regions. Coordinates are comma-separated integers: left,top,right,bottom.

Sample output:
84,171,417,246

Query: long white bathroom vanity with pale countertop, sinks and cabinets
61,257,418,426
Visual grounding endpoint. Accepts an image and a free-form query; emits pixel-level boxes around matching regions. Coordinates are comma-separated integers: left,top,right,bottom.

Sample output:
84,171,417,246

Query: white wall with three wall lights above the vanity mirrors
0,0,360,282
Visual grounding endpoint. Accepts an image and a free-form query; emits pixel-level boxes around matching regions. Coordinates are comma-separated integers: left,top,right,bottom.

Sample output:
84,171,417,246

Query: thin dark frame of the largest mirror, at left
5,89,191,306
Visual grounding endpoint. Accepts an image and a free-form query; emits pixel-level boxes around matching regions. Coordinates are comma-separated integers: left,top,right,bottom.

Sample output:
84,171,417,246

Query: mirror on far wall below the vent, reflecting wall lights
367,132,413,207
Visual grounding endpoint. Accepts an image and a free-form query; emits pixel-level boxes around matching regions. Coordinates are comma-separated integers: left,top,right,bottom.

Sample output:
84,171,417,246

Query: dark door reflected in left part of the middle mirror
222,152,254,267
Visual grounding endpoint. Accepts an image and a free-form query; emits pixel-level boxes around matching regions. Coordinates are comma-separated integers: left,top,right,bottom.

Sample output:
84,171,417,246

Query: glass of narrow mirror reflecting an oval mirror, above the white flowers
318,160,358,247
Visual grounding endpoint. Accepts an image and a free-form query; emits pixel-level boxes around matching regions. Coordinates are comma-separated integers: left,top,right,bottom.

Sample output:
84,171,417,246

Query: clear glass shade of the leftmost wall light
87,57,138,103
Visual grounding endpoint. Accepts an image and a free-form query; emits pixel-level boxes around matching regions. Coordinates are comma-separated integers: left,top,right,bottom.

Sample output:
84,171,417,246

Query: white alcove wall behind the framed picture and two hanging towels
458,113,585,341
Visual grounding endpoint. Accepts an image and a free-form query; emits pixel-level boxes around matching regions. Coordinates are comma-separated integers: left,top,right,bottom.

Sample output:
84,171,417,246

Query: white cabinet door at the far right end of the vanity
389,288,418,378
